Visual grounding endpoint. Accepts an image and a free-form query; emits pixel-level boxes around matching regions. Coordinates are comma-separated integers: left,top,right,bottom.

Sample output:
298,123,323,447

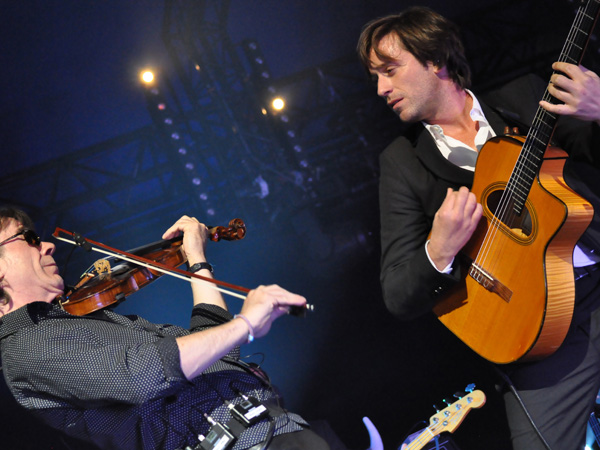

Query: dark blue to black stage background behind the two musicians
0,0,598,450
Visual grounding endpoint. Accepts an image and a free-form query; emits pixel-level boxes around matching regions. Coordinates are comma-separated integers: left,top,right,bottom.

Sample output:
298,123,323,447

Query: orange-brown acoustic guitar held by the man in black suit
434,0,600,364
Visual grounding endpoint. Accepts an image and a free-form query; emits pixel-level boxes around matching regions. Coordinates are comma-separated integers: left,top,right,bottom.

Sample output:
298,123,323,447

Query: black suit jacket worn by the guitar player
379,77,600,319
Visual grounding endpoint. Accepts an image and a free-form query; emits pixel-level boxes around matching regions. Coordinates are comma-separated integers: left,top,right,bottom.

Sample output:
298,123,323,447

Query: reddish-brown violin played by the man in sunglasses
54,219,246,316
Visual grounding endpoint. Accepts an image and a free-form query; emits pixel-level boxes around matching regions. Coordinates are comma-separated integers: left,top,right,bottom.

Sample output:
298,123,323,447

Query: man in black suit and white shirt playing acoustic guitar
358,7,600,450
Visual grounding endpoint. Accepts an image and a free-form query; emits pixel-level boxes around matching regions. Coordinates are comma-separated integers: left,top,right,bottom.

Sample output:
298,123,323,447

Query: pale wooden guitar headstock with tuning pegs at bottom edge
405,390,485,450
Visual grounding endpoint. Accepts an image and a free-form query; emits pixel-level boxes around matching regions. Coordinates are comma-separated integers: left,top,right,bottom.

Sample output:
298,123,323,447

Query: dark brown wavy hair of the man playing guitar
357,6,471,89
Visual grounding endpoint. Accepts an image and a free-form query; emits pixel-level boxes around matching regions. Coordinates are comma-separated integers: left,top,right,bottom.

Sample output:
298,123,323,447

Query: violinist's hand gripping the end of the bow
240,284,306,337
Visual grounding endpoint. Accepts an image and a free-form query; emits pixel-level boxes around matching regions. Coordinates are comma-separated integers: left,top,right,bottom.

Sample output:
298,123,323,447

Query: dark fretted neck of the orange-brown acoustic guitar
507,0,600,214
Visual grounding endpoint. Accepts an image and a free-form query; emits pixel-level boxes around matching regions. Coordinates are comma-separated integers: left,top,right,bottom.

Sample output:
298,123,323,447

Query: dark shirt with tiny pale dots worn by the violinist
0,302,306,450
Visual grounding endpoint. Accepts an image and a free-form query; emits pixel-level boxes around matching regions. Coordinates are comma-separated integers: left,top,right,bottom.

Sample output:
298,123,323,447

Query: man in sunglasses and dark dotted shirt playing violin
0,208,329,450
